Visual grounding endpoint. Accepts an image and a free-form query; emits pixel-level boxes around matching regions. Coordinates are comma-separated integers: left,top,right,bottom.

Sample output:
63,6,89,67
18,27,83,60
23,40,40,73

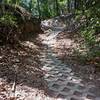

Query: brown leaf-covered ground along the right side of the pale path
53,32,100,81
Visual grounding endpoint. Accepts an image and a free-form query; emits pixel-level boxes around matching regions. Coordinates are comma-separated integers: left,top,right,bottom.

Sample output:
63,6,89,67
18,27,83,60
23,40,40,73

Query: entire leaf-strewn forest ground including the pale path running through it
0,19,100,100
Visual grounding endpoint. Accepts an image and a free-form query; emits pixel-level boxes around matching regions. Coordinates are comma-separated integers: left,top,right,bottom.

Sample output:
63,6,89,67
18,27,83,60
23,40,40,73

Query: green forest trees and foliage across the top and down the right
0,0,100,55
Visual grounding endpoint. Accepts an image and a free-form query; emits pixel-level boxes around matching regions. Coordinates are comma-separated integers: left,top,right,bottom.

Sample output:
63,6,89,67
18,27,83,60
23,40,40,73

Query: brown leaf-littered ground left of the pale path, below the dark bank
0,35,47,100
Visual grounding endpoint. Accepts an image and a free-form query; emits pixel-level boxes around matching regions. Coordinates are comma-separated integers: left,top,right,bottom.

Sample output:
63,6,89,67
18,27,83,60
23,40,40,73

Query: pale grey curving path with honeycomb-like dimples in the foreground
38,23,100,100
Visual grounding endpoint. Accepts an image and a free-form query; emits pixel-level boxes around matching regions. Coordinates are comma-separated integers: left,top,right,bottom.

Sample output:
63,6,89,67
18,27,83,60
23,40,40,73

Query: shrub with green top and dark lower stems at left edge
0,12,19,43
